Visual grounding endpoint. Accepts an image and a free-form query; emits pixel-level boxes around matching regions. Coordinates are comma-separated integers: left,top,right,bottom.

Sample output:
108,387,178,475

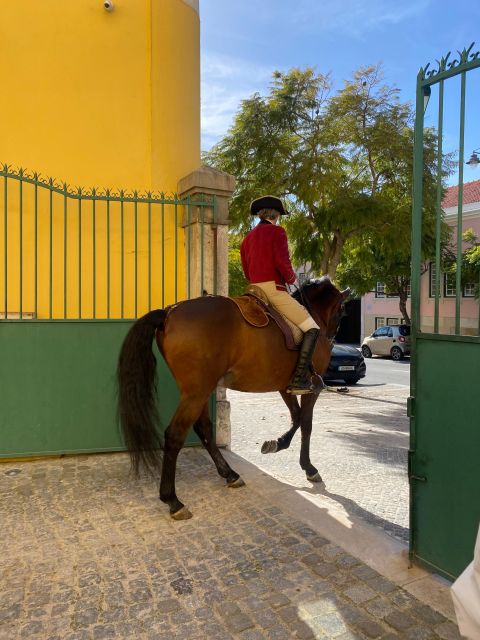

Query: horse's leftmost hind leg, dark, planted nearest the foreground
160,397,205,520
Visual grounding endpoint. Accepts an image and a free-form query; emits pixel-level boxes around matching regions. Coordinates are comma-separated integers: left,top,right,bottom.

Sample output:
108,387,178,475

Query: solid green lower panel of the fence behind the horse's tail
0,320,204,458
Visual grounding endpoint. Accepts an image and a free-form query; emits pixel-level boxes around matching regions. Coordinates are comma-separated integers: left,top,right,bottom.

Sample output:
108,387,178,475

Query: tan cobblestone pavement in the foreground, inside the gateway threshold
0,448,459,640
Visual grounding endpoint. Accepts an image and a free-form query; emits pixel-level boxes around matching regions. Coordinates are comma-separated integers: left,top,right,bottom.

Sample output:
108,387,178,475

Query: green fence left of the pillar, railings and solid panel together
0,165,216,458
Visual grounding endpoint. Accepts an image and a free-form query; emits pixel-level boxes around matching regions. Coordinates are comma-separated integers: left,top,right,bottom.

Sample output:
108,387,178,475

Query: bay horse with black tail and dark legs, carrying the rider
117,276,350,520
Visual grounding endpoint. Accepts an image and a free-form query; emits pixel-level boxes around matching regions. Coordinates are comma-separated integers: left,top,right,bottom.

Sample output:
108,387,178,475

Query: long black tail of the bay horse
117,309,167,475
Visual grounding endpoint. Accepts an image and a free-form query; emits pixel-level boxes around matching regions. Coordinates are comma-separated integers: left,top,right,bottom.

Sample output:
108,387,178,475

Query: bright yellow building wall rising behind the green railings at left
0,0,200,317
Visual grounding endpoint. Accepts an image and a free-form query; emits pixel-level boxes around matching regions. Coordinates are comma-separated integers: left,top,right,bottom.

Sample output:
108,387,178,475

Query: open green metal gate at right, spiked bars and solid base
409,45,480,579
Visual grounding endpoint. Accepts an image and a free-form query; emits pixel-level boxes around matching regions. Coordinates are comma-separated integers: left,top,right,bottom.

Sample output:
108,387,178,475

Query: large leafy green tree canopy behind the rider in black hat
205,66,450,314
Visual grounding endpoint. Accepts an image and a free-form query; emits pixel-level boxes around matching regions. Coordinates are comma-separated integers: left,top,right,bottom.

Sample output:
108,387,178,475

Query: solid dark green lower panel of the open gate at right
411,334,480,579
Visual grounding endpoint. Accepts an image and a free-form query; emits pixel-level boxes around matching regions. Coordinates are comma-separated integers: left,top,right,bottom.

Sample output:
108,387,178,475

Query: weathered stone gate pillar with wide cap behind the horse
178,167,235,447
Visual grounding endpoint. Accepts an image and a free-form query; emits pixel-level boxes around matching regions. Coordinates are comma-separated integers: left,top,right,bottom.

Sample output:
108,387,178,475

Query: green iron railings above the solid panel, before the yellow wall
0,165,216,320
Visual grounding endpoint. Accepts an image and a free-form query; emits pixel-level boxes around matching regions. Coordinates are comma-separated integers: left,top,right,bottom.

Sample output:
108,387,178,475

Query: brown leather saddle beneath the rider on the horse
230,284,303,351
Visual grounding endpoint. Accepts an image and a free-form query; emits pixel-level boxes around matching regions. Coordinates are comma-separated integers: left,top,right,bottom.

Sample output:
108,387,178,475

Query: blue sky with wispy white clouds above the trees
200,0,480,181
